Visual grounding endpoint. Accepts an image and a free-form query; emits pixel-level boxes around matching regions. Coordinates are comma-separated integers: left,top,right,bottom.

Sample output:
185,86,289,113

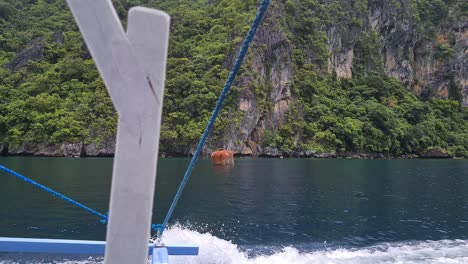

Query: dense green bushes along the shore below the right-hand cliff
265,71,468,155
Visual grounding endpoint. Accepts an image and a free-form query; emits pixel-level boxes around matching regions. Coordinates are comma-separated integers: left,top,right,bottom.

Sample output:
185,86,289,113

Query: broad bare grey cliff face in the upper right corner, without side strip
369,1,468,102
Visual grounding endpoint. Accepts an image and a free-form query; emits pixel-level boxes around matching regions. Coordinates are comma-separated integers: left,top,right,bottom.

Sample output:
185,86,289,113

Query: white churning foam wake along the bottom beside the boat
0,226,468,264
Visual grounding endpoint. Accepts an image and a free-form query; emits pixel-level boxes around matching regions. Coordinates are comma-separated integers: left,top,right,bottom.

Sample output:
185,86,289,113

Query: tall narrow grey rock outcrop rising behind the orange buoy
224,5,293,156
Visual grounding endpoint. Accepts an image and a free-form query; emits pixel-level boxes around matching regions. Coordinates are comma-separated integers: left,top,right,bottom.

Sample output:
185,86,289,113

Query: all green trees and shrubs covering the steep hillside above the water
0,0,468,156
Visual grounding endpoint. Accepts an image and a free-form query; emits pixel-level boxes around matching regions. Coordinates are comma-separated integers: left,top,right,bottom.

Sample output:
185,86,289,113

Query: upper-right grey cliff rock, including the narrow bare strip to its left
326,0,468,103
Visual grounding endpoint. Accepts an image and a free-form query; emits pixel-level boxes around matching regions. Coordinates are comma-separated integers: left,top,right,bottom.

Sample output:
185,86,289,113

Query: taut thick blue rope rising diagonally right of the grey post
157,0,270,236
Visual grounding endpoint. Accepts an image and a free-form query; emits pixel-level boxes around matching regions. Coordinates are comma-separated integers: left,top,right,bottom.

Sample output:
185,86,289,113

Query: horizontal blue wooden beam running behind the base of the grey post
0,237,198,256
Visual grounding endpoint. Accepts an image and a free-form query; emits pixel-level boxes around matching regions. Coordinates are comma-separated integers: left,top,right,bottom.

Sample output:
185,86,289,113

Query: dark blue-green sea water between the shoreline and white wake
0,157,468,263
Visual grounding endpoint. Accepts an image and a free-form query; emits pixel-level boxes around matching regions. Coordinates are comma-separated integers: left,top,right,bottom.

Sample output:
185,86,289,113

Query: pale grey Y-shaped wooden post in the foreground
67,0,169,264
